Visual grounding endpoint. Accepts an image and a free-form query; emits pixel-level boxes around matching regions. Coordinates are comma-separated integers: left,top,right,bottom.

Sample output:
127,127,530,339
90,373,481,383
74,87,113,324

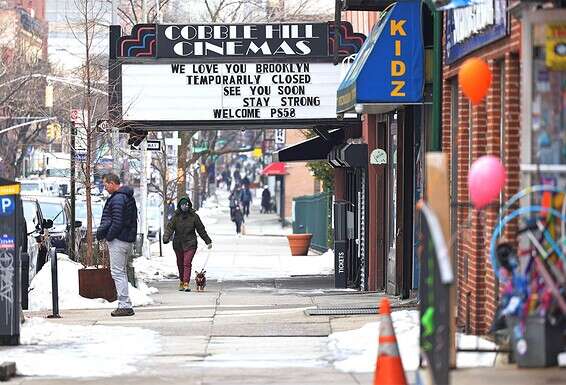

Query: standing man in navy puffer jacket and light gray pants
96,174,138,317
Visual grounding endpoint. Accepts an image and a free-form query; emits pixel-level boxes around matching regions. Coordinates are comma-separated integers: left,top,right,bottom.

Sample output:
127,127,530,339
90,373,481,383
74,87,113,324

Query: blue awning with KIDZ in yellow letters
337,0,424,113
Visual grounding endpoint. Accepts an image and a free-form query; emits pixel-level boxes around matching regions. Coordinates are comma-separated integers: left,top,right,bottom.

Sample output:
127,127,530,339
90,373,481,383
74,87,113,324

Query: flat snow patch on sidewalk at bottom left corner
0,318,161,378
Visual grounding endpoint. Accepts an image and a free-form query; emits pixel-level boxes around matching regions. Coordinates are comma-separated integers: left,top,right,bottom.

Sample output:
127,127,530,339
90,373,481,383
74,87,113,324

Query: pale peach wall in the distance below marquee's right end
285,130,315,222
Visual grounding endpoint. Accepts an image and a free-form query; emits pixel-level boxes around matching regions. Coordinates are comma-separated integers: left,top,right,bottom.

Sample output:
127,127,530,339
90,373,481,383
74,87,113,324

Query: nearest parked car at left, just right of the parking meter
22,196,51,281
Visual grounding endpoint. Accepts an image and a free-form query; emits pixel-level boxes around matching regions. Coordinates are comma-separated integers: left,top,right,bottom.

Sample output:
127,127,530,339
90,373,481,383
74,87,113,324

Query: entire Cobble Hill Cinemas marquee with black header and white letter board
109,23,365,129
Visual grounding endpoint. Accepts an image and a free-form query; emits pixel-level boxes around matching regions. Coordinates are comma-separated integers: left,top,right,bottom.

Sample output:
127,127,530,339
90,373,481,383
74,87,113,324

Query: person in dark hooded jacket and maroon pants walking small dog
163,197,212,292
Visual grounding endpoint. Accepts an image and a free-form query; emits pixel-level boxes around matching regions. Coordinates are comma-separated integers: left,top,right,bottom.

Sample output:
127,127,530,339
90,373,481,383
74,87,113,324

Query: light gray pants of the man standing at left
108,239,132,309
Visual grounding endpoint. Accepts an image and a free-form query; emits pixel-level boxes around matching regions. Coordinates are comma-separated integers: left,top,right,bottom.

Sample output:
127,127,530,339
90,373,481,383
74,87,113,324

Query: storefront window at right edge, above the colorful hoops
531,24,566,171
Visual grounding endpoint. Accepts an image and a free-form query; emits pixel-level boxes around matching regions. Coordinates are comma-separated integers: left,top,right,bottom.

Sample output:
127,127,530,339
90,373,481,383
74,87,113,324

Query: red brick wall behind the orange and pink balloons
442,14,521,334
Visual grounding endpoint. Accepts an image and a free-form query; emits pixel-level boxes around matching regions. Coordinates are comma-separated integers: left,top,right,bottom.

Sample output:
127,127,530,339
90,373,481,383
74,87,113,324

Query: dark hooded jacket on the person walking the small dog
163,197,212,251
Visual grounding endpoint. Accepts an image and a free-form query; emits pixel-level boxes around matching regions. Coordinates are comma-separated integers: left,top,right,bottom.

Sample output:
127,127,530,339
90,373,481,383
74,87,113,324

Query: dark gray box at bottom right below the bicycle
508,317,564,368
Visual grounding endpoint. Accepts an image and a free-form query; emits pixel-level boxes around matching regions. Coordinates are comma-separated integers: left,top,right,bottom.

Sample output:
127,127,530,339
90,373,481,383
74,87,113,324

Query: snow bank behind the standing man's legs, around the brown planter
29,254,157,311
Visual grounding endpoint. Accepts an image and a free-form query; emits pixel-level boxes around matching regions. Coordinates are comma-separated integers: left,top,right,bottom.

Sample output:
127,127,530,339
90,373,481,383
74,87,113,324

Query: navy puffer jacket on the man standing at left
96,186,138,243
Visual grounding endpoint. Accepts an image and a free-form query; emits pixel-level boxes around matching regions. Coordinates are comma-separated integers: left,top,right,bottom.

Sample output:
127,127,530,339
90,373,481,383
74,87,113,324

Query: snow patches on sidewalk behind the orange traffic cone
328,310,496,373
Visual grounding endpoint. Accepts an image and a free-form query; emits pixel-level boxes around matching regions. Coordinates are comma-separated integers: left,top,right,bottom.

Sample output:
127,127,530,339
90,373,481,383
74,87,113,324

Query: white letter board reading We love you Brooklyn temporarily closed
122,63,340,121
